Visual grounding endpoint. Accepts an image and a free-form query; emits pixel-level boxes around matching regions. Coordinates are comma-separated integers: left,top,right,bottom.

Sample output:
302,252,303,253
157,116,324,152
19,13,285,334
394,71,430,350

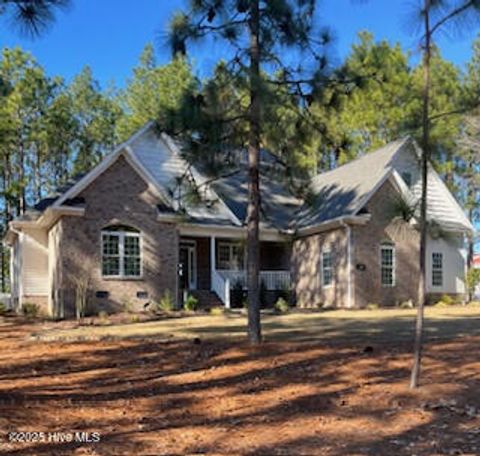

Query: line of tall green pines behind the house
0,32,480,287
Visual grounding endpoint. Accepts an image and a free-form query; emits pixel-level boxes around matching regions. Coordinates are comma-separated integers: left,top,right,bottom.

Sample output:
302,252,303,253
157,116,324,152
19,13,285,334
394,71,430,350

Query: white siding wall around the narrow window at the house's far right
426,234,467,293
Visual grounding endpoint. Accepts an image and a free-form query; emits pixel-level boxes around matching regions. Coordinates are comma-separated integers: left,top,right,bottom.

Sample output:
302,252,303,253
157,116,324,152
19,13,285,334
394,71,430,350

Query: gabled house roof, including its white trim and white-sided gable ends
14,122,473,235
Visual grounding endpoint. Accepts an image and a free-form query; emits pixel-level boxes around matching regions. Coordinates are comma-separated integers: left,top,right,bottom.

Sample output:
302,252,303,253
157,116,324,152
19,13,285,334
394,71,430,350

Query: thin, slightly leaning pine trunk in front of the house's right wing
410,0,431,388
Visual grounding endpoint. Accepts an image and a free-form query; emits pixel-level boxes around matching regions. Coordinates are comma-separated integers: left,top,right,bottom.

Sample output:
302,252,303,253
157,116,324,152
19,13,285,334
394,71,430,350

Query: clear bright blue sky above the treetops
0,0,475,86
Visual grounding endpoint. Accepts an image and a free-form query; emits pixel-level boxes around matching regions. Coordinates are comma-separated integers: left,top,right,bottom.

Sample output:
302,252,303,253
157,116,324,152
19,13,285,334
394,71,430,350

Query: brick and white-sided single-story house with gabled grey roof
6,123,473,316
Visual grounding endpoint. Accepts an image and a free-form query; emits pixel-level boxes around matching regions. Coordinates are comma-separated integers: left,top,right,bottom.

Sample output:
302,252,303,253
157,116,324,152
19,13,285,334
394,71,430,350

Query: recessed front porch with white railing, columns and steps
179,236,291,308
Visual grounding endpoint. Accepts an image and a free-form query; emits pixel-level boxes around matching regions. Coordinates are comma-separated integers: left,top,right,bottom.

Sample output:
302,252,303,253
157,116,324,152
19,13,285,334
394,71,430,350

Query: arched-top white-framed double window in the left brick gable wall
102,226,142,277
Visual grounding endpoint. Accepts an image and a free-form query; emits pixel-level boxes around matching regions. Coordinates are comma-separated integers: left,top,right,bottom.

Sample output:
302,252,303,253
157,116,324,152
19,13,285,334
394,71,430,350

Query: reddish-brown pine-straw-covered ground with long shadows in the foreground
0,315,480,456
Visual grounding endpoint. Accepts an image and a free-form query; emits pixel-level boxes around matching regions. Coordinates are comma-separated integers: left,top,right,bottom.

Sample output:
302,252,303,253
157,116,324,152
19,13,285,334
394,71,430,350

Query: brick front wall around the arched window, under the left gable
52,157,178,317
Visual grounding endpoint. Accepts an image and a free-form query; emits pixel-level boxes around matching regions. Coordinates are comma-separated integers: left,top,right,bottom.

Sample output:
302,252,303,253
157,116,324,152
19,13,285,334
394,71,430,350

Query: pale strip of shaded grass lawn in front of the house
34,305,480,341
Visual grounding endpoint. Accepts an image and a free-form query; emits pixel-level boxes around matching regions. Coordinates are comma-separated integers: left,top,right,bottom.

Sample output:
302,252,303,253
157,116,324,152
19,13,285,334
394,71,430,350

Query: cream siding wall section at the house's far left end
20,230,49,296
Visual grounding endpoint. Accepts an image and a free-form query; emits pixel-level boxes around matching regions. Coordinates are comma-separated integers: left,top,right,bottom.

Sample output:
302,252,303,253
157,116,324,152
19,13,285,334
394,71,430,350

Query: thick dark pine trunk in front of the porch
247,0,262,344
